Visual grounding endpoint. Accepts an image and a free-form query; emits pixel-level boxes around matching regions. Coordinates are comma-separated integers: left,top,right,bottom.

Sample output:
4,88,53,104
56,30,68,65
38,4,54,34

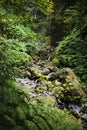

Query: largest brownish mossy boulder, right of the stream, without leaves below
58,68,84,98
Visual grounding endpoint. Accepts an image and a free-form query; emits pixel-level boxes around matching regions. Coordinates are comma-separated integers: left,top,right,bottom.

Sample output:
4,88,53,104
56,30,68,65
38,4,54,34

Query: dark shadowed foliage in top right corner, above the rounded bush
64,1,87,34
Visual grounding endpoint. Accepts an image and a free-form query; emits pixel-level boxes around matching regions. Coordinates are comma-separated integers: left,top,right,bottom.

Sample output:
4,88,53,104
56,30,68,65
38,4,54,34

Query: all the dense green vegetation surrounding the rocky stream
0,0,87,130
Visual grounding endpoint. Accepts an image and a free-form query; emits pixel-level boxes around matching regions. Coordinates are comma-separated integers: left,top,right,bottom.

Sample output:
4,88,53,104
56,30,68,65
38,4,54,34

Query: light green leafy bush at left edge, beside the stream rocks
0,37,31,83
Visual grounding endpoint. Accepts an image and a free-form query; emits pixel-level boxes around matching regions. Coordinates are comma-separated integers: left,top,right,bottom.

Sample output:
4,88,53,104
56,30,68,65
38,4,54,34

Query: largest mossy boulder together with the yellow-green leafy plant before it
57,68,85,102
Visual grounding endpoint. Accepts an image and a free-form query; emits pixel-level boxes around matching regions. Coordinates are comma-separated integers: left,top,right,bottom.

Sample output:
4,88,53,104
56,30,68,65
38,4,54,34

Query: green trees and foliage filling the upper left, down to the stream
0,0,53,83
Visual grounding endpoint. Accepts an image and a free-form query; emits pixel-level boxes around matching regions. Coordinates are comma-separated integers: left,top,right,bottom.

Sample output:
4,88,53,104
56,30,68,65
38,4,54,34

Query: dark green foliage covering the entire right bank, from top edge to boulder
54,1,87,94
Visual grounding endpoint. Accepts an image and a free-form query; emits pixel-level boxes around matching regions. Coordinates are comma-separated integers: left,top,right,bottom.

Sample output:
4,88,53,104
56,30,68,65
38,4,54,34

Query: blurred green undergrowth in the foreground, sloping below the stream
0,81,83,130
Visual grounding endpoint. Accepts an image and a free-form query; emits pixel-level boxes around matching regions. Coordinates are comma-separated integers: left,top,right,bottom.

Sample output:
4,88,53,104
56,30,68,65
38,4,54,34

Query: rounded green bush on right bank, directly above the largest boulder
54,33,87,91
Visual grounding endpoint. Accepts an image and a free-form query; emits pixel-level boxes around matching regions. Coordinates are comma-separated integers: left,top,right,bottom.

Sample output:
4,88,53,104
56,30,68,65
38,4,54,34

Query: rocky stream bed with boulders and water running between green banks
17,61,87,128
